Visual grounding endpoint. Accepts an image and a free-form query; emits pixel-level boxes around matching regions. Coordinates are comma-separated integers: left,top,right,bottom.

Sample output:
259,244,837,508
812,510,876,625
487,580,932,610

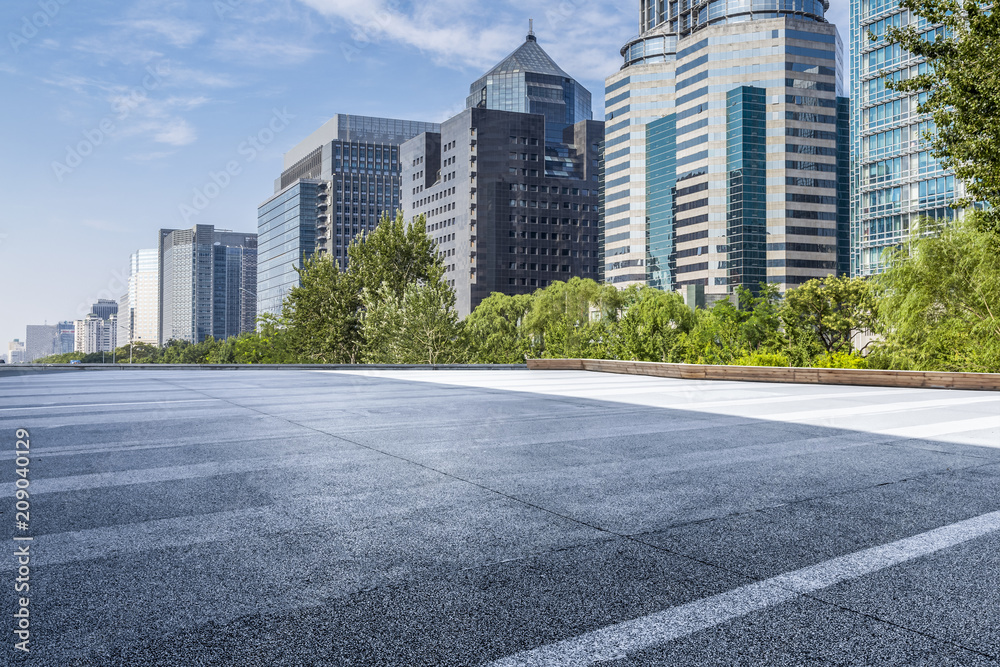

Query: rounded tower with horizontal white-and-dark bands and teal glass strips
603,0,849,300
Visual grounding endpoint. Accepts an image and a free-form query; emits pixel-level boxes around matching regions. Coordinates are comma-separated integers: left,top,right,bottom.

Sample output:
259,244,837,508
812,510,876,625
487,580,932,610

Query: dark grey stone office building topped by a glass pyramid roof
401,35,604,317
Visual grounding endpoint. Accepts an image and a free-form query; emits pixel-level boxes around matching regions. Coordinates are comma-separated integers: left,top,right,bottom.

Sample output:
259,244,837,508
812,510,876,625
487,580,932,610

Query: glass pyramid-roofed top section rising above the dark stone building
466,31,594,144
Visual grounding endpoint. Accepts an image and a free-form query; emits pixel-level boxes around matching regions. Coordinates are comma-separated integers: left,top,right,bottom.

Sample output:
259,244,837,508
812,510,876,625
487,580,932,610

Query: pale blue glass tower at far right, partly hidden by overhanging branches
851,0,963,276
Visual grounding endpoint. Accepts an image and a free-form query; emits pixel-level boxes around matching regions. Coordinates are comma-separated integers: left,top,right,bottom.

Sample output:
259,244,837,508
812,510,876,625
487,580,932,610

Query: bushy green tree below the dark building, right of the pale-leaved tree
462,292,532,364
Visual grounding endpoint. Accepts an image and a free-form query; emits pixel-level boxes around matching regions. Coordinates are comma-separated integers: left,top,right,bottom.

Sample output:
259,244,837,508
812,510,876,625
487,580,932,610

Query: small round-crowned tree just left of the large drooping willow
781,276,878,356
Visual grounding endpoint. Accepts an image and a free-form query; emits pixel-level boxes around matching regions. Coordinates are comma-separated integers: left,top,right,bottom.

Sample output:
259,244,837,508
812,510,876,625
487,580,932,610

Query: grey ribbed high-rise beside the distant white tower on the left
158,225,257,345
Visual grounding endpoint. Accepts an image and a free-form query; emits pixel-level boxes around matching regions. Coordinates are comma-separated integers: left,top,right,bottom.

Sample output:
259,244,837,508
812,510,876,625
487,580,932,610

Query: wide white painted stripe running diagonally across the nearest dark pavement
488,512,1000,667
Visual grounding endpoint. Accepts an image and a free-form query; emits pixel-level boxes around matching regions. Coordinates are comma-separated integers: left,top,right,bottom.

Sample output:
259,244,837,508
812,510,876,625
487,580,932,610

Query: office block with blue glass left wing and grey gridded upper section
257,114,440,314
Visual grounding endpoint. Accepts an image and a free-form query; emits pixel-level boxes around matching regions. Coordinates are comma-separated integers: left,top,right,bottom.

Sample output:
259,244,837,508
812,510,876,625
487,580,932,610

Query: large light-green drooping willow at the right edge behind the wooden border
872,220,1000,373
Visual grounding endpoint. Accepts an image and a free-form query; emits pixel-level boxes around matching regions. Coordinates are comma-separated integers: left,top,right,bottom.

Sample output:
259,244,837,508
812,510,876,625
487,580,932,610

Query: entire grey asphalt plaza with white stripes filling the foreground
0,371,1000,667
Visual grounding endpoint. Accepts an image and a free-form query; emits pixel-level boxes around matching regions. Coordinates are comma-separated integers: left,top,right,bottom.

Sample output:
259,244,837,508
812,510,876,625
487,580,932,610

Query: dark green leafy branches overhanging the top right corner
887,0,1000,230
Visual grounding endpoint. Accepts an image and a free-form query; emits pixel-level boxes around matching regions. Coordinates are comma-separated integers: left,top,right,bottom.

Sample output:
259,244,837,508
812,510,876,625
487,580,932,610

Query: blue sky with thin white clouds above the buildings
0,0,848,354
